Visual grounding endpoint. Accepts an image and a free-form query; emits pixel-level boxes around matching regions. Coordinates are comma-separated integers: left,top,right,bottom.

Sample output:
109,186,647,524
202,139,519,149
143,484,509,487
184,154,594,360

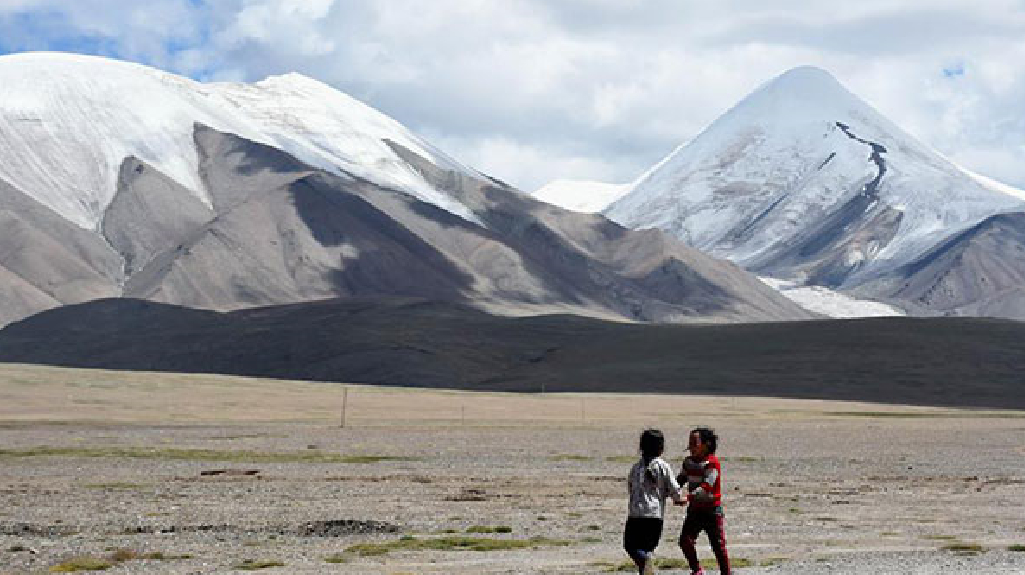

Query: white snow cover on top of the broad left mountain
0,52,479,229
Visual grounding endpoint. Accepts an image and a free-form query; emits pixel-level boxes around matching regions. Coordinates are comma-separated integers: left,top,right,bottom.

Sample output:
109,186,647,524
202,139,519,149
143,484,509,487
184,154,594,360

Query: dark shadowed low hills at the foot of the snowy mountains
0,297,1025,409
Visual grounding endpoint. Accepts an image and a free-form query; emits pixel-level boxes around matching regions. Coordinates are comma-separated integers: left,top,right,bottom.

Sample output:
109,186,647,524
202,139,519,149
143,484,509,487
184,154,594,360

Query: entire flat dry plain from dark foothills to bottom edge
0,365,1025,574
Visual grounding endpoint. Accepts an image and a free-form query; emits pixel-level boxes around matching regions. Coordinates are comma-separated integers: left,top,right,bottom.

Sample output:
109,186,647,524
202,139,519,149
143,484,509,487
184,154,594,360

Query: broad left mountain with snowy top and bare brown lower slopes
0,53,811,325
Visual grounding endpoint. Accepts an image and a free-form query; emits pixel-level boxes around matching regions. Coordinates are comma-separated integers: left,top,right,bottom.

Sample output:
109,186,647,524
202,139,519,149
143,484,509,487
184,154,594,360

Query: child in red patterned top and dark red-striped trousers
677,427,730,575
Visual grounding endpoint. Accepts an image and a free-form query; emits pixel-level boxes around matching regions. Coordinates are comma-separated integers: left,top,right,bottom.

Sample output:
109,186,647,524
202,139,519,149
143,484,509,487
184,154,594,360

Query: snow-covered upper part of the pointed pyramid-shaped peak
604,67,1025,295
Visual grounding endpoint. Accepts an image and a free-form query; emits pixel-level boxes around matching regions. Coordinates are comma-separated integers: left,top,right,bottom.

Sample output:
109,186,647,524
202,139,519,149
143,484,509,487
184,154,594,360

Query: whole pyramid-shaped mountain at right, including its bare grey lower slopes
547,67,1025,319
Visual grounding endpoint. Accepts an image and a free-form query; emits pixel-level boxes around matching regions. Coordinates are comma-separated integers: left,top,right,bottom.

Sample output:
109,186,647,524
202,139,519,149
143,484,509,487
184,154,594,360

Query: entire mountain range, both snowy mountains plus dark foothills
6,53,1025,407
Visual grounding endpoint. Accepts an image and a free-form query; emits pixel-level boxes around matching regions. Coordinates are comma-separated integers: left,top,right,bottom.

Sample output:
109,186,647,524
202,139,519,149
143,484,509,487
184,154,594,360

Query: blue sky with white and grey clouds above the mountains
0,0,1025,191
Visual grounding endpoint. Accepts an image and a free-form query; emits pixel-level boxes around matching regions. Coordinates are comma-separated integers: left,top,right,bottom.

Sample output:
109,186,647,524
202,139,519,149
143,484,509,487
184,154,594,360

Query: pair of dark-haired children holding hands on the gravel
623,427,730,575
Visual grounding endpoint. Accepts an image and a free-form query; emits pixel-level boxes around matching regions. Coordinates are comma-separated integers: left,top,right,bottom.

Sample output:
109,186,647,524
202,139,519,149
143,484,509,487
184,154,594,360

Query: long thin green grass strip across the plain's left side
0,446,417,463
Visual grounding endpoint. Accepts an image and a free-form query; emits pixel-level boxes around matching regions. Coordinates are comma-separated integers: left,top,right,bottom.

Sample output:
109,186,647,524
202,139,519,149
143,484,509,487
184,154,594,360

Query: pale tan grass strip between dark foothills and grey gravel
0,364,1000,426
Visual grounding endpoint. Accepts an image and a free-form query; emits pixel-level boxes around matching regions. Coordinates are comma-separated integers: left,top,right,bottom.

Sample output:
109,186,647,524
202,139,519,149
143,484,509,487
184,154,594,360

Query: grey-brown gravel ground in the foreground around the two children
0,407,1025,573
